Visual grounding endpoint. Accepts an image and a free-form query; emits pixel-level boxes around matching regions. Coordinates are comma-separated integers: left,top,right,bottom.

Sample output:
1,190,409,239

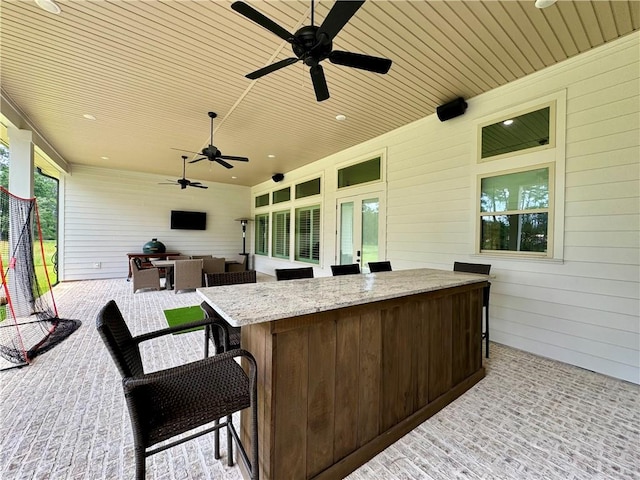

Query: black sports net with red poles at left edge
0,187,81,366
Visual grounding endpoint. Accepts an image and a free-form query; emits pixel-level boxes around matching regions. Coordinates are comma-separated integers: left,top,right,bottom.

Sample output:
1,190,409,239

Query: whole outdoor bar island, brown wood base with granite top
198,269,487,480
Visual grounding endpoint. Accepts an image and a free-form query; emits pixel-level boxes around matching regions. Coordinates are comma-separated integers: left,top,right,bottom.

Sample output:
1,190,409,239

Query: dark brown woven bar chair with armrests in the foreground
96,300,259,480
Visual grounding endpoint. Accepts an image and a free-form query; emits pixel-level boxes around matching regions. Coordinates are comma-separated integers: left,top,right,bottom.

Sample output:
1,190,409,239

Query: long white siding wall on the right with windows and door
252,34,640,383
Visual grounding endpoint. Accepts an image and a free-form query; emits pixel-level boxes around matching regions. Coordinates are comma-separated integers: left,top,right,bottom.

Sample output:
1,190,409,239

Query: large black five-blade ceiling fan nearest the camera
231,0,392,102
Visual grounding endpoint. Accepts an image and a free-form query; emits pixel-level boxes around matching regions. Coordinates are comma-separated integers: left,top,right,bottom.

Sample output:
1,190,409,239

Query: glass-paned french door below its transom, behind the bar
336,193,385,272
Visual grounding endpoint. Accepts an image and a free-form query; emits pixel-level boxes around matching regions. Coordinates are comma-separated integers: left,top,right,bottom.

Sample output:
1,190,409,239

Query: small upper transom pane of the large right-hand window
480,104,555,161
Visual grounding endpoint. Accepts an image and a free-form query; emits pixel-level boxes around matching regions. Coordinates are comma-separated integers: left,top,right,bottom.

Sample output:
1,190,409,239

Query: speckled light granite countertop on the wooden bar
197,268,489,327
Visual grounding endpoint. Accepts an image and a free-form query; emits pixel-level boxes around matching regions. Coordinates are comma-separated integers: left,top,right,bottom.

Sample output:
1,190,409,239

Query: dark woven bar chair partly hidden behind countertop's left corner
200,270,256,356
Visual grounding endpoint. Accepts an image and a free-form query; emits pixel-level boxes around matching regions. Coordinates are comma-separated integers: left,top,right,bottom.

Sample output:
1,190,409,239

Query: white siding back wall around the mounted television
59,167,250,281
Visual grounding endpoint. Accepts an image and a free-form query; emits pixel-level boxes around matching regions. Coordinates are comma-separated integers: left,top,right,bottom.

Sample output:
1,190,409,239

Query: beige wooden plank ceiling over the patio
0,0,640,185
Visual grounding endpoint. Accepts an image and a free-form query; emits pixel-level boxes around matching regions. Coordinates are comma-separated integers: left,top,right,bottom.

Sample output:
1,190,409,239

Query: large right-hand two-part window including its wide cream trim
472,90,567,261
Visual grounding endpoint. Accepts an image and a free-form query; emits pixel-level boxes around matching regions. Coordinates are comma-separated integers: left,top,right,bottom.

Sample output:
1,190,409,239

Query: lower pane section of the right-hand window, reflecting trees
480,165,553,256
